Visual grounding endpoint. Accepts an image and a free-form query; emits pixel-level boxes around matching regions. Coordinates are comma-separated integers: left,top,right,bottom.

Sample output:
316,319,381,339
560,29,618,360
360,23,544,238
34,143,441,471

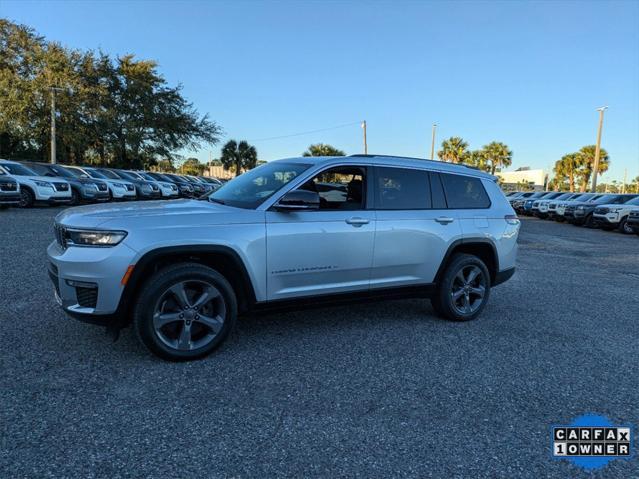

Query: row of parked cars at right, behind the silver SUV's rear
506,191,639,235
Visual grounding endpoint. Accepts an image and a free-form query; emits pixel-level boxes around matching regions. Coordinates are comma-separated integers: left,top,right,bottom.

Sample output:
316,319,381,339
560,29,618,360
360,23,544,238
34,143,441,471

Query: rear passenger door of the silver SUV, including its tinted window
371,166,461,289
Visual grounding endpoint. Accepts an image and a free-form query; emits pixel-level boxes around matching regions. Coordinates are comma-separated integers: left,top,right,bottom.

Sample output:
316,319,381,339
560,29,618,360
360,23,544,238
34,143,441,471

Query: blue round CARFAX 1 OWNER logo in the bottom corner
552,414,633,469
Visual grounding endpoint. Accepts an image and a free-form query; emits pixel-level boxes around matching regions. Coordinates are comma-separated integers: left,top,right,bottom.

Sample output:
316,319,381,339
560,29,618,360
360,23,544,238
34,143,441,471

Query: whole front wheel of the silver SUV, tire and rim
133,263,237,361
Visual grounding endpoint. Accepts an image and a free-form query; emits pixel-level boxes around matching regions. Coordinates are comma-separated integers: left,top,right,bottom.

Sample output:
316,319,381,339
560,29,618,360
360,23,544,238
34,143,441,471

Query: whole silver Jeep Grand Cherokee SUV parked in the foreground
48,155,519,360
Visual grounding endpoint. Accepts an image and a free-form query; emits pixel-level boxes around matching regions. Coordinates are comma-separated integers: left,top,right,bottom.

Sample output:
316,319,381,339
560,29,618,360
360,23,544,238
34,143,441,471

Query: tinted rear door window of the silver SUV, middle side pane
375,168,431,210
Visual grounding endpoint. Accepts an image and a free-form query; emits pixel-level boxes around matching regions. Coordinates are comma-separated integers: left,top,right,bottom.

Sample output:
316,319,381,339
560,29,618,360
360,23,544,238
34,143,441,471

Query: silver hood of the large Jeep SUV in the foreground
55,200,255,229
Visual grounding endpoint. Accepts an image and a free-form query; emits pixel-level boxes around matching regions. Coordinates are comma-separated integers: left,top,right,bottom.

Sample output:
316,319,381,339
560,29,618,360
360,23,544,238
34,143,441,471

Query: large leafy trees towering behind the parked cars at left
0,19,221,168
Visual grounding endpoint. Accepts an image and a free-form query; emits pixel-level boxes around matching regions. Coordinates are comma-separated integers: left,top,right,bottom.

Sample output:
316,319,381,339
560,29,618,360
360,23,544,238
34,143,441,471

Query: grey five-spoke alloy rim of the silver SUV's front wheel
153,280,226,351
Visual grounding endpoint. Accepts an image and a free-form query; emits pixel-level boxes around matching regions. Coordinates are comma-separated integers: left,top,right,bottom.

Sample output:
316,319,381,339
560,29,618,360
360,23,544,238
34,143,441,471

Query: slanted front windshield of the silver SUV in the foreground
209,161,311,209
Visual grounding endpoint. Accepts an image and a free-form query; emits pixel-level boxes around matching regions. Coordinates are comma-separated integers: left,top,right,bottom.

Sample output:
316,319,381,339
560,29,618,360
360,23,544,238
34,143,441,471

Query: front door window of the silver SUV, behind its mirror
298,166,366,210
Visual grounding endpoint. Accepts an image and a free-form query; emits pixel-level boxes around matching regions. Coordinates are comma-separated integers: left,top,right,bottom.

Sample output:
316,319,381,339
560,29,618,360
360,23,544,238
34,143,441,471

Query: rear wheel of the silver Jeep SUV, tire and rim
431,254,490,321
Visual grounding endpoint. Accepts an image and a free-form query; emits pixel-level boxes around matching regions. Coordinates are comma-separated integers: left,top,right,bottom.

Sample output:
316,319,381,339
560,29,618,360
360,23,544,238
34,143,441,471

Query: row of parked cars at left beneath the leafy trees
0,159,222,208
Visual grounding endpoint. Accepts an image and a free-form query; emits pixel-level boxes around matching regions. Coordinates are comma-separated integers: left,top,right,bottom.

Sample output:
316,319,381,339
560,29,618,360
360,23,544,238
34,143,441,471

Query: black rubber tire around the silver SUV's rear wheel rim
431,254,490,321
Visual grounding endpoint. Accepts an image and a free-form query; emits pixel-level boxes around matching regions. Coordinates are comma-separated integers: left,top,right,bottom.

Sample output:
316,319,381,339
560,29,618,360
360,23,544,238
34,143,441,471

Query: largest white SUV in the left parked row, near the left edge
0,160,72,208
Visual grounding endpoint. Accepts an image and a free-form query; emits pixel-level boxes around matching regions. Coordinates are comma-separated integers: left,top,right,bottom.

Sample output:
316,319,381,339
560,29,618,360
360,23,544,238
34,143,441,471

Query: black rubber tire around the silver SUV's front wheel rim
133,263,237,361
